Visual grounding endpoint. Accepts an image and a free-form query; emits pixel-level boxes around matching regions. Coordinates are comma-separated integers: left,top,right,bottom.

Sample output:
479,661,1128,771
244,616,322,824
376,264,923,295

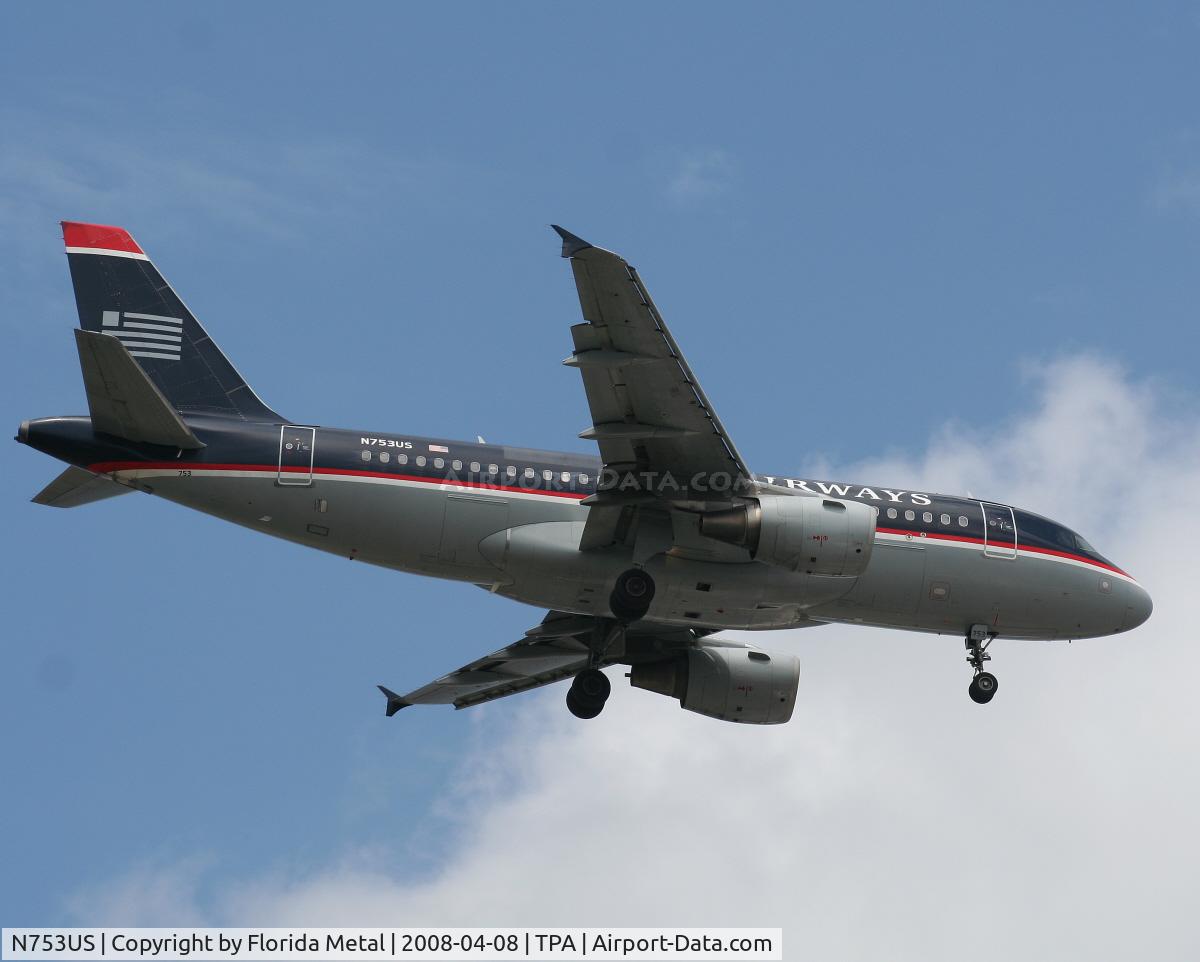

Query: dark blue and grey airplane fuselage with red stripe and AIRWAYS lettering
19,415,1150,639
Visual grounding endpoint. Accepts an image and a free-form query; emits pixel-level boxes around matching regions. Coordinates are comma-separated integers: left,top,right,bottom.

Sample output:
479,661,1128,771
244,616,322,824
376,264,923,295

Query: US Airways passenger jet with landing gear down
17,222,1153,724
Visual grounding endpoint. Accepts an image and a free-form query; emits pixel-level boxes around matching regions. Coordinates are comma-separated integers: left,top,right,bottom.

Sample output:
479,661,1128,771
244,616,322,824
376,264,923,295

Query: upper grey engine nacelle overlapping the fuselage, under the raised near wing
700,494,877,578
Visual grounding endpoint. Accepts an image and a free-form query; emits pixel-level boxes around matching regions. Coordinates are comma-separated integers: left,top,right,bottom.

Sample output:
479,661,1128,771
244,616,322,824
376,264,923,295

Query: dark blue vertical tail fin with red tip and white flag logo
62,221,282,421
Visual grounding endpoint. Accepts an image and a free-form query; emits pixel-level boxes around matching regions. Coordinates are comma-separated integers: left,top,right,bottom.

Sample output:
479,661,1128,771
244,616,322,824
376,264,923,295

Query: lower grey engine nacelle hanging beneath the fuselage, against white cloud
629,642,800,724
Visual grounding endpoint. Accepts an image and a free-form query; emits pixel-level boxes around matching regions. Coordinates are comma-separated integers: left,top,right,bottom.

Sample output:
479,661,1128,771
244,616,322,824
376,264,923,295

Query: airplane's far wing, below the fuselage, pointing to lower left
378,612,707,717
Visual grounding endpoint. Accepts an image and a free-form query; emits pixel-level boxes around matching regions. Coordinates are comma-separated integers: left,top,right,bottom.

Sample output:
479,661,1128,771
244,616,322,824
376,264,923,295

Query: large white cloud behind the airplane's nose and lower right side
73,357,1200,962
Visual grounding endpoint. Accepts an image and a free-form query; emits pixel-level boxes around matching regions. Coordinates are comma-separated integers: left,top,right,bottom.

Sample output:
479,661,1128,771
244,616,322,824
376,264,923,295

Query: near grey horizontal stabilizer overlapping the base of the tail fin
76,331,204,450
